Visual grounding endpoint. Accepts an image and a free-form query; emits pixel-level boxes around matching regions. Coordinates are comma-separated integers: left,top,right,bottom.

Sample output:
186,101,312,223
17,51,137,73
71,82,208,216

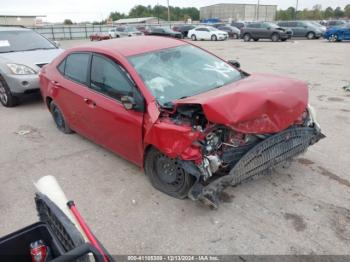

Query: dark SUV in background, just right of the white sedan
241,22,293,42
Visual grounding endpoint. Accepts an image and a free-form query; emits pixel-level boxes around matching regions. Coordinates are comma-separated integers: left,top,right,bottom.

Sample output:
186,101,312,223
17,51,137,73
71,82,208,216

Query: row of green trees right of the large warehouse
276,4,350,20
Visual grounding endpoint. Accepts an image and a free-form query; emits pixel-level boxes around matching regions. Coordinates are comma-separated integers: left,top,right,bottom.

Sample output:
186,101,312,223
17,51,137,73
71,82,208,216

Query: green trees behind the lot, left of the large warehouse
109,5,199,21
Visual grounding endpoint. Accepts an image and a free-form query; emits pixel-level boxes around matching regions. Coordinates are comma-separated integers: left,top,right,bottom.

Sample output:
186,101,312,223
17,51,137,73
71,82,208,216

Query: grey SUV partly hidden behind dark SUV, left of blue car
278,21,322,39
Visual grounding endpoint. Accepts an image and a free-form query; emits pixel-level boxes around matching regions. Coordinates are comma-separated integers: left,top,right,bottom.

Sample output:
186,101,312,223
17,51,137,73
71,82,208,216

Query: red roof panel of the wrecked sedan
69,36,188,56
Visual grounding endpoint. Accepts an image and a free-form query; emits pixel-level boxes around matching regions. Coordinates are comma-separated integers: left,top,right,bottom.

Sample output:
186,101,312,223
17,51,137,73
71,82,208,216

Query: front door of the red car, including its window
86,54,143,165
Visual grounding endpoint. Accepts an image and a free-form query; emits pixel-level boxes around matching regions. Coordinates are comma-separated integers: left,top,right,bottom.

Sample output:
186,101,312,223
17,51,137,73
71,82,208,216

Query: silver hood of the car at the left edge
0,48,64,70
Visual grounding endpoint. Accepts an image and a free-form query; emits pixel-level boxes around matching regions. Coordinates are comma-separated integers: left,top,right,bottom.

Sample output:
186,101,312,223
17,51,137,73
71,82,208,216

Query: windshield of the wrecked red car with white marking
129,45,241,105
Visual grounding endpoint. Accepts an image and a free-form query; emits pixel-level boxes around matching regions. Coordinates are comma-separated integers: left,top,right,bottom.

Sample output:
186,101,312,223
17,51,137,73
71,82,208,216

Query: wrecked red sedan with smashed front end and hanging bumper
40,36,323,207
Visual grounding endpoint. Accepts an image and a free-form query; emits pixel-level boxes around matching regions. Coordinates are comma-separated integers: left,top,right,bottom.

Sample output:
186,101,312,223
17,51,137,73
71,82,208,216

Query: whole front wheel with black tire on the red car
145,147,195,199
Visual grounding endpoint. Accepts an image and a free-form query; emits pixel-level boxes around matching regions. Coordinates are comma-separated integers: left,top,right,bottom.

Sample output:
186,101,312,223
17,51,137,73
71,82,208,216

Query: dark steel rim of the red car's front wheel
156,155,185,191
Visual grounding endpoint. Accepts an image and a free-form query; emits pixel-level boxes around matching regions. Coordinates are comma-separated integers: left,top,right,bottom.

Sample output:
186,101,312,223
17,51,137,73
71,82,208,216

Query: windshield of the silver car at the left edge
0,30,56,53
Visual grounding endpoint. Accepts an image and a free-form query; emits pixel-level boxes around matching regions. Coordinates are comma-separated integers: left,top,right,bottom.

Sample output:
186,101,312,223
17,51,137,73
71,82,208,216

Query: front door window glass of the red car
90,55,133,100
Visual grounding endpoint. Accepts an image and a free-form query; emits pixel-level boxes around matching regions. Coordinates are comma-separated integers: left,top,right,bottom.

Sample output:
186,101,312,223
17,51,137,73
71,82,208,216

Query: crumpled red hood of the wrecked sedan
174,74,308,134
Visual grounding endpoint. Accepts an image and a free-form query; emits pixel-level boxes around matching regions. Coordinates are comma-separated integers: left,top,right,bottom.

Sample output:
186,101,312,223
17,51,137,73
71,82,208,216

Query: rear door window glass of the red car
64,53,90,84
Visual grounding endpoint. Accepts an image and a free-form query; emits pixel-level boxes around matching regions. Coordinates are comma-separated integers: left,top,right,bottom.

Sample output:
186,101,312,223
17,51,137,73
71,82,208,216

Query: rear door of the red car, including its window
51,52,93,139
